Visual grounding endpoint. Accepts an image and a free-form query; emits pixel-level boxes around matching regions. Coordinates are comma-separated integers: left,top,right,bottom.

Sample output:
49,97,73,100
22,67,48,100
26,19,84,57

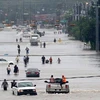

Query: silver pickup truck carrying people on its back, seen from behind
45,78,69,93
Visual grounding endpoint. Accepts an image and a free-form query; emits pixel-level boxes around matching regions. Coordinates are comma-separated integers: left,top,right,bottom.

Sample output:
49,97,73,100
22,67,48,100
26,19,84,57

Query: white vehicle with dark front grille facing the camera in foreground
12,81,37,95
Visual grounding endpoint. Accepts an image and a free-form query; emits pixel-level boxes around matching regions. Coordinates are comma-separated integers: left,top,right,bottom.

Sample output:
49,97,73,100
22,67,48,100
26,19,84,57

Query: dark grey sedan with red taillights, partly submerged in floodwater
26,68,40,77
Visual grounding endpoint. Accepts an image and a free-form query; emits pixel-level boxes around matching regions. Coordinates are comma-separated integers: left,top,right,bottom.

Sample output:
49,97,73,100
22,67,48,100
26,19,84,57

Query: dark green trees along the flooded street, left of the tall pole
68,7,96,50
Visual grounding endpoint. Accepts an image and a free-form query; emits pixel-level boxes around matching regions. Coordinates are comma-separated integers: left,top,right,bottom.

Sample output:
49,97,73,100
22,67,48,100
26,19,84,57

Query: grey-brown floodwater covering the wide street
0,29,100,100
